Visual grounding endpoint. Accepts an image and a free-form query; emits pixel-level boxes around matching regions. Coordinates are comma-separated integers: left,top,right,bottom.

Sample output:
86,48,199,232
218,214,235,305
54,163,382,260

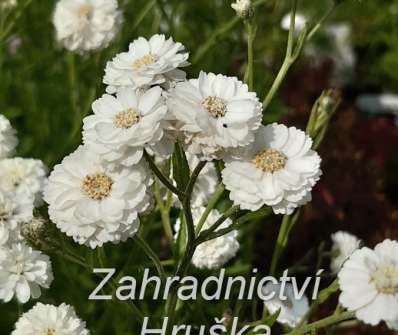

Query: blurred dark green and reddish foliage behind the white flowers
0,0,398,335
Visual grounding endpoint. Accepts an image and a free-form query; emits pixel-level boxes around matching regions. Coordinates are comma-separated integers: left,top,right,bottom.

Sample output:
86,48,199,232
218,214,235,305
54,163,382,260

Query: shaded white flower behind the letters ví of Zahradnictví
262,283,309,328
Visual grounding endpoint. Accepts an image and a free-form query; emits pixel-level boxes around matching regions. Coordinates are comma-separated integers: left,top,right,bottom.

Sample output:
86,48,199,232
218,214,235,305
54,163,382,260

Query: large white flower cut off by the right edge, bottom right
338,240,398,326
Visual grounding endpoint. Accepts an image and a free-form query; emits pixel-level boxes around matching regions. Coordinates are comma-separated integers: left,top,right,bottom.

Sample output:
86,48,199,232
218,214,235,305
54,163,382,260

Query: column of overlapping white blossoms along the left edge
0,115,53,303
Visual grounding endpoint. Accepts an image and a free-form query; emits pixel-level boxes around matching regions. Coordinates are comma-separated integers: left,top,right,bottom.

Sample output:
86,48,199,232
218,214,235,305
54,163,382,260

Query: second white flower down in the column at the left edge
0,157,47,205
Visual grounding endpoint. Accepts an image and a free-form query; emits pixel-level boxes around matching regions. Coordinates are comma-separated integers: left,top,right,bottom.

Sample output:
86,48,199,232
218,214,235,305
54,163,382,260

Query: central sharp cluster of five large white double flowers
45,35,321,267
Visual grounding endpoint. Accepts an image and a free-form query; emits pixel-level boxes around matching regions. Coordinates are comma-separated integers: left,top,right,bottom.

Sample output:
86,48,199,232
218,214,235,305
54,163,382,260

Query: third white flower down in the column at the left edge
0,192,33,246
